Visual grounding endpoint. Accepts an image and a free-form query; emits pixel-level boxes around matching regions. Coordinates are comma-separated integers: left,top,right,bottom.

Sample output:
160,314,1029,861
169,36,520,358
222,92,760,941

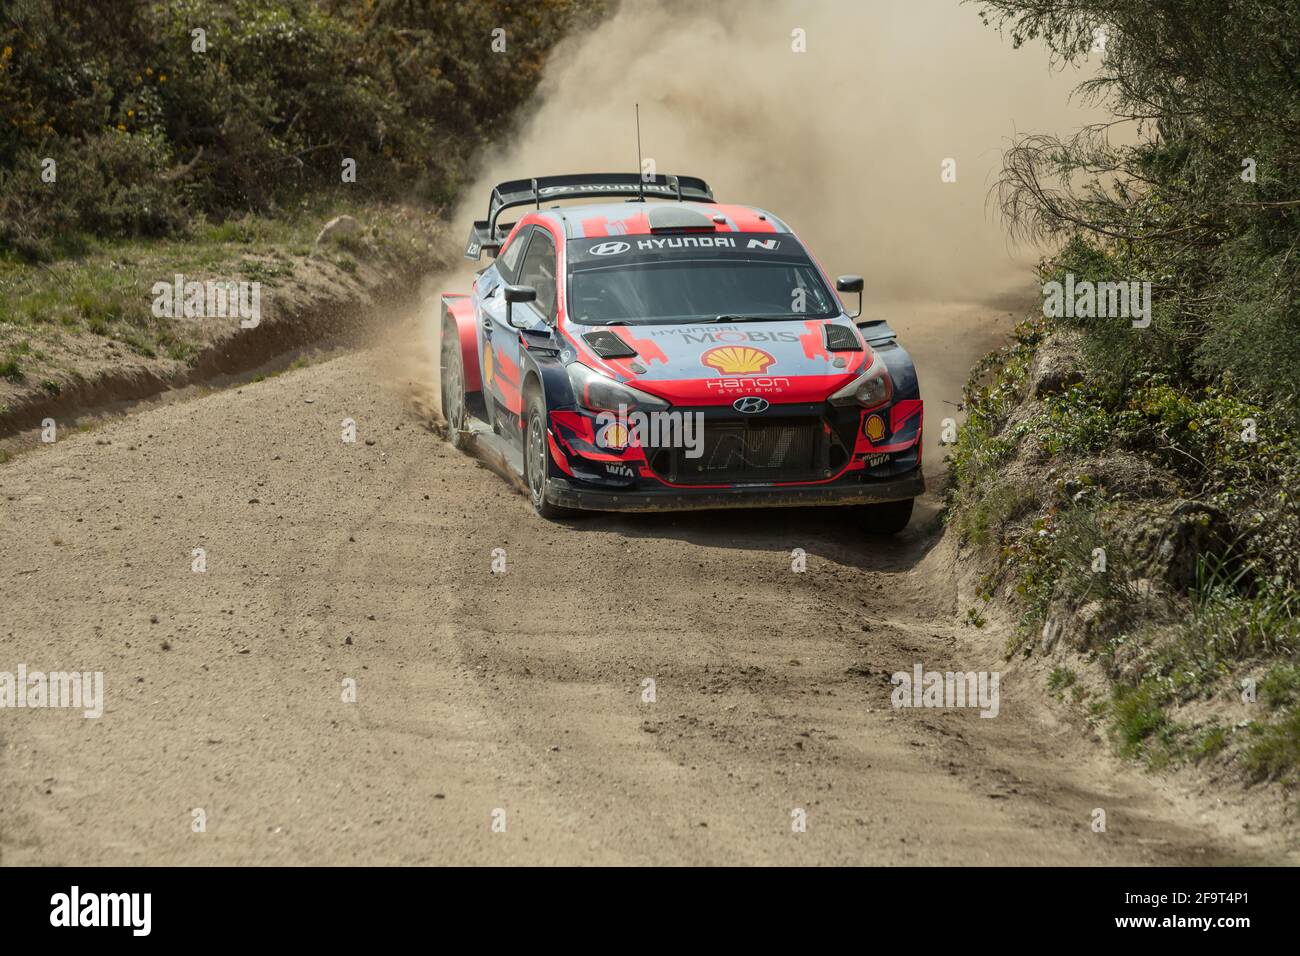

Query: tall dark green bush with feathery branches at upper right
976,0,1300,421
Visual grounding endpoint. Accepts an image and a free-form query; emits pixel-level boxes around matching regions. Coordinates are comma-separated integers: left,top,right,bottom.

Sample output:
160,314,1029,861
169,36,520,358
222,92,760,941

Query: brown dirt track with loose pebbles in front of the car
0,300,1289,864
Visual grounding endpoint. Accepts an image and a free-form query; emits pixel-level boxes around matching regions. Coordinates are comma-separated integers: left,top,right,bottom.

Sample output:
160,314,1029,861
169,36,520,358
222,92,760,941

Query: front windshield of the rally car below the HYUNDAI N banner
568,237,840,325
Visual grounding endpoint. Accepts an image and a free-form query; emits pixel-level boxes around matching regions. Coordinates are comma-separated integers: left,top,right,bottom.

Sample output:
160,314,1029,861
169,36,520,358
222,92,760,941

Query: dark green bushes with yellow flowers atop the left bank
0,0,603,259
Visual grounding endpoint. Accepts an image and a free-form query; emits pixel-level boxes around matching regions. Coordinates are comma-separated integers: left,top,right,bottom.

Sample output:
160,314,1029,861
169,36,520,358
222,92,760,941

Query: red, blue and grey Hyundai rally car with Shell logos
441,173,924,533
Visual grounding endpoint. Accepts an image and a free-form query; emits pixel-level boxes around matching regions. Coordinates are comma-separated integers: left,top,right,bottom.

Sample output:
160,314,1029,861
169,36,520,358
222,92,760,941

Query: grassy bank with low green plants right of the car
945,314,1300,782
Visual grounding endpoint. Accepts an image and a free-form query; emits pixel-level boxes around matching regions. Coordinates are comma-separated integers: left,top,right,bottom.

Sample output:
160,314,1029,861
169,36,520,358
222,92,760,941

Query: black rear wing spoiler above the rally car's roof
465,173,714,261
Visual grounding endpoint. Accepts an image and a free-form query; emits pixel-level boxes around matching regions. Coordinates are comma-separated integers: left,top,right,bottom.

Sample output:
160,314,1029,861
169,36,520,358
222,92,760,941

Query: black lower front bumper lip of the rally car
546,468,926,511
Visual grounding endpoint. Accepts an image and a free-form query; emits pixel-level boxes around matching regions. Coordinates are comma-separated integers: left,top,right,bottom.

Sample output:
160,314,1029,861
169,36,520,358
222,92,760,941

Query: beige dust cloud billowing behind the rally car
413,0,1099,447
